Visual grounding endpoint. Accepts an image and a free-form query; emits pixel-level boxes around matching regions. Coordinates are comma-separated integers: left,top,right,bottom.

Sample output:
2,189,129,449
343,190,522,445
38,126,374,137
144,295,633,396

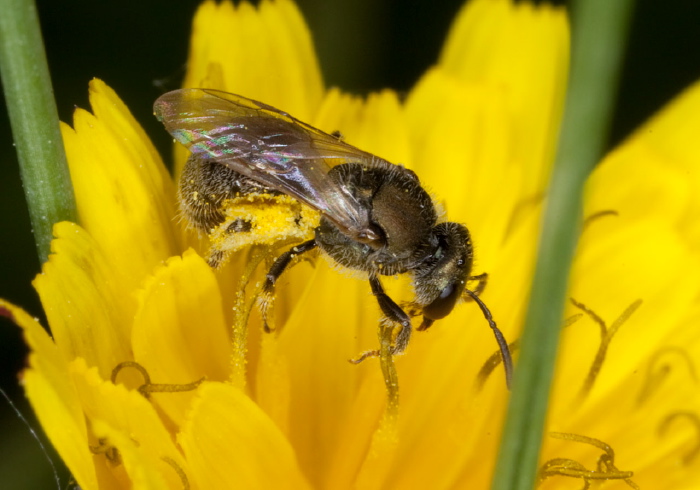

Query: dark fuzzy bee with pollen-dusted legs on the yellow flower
154,89,512,380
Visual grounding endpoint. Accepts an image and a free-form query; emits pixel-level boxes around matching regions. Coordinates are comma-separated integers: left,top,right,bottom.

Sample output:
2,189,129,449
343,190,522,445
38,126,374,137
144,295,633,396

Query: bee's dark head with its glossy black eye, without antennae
413,222,472,328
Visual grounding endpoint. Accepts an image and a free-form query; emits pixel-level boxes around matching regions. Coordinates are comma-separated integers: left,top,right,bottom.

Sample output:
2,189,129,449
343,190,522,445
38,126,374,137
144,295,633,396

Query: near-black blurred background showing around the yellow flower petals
0,0,700,489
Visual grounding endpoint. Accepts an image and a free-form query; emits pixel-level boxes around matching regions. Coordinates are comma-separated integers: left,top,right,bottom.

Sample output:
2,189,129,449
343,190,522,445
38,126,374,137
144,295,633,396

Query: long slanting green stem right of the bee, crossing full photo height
492,0,634,490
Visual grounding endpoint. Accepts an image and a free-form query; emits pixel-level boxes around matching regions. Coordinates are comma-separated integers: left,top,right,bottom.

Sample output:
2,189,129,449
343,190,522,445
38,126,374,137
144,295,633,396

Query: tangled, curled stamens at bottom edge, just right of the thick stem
537,432,639,490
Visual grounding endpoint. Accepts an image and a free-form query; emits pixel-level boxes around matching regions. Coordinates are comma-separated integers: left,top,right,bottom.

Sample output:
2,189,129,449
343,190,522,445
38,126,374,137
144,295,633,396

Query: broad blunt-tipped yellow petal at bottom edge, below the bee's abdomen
178,383,308,489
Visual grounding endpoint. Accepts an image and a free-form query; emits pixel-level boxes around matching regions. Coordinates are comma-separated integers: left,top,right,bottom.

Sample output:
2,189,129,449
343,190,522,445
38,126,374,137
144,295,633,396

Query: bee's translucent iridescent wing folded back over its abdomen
154,89,379,241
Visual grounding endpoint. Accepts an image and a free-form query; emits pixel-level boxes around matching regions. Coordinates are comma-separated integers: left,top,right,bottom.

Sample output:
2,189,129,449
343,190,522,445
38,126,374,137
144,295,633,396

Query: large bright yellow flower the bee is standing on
1,0,700,489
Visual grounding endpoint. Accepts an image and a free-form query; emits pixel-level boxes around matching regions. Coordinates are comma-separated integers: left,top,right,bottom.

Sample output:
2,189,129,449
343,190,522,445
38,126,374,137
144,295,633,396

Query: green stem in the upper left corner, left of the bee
0,0,77,262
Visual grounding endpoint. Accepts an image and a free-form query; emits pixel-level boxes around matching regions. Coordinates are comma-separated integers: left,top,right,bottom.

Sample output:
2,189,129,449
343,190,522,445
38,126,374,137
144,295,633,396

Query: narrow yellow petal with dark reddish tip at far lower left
0,300,97,489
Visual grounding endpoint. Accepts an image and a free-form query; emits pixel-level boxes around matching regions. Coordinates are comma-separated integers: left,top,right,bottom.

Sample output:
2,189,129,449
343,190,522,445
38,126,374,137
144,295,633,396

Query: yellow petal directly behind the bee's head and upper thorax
406,68,533,270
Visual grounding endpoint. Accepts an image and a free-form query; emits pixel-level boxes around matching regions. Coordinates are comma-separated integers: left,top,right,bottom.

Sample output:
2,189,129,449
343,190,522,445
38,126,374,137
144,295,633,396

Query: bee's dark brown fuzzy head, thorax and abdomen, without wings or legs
179,155,472,330
